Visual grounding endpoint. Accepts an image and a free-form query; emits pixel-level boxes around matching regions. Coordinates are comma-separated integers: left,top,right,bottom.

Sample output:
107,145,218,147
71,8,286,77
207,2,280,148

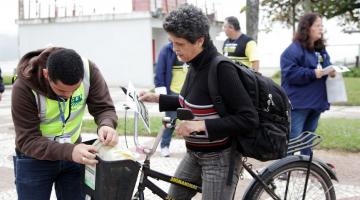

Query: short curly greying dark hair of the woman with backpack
163,4,210,46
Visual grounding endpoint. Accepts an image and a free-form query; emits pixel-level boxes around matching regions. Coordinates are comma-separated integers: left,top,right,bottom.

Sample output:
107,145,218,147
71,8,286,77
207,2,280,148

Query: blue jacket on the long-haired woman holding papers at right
280,42,331,112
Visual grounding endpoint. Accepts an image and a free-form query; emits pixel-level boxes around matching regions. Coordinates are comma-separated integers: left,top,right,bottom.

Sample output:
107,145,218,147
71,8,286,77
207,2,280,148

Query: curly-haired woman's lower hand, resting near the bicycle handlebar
175,120,206,136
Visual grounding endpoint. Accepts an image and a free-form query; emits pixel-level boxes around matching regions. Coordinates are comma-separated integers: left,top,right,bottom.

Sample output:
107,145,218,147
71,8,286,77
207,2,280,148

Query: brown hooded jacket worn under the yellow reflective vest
11,47,117,161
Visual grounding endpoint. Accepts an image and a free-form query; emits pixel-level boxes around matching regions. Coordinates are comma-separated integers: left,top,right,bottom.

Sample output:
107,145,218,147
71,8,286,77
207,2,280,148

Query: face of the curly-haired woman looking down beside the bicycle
169,34,204,62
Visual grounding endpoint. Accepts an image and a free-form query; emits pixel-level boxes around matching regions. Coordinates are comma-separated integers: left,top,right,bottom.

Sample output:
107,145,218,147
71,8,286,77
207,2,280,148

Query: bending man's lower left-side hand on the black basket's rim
72,144,98,165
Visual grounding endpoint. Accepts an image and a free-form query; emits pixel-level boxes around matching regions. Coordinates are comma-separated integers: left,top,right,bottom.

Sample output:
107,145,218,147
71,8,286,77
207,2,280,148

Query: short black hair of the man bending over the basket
46,49,84,85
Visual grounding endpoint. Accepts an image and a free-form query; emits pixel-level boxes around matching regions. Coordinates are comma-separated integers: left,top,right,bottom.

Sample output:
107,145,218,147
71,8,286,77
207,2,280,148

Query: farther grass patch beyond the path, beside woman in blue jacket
273,77,360,106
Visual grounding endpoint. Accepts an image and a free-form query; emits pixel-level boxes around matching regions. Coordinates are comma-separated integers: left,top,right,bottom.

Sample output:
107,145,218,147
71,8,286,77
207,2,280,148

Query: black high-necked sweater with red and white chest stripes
159,44,259,151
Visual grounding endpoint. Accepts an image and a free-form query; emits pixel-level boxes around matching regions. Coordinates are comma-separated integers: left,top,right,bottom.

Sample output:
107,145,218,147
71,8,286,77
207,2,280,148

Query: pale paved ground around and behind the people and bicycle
0,85,360,200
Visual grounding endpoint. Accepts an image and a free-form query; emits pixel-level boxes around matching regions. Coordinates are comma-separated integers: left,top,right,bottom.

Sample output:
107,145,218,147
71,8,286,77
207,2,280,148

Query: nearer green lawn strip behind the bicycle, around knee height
82,117,360,152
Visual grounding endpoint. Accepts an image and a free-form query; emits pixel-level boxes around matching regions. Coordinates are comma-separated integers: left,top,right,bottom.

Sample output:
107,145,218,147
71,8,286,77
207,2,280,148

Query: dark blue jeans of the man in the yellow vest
14,153,85,200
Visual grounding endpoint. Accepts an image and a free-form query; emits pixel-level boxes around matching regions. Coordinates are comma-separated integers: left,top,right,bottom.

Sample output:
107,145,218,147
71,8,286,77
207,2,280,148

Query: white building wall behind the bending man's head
19,13,153,87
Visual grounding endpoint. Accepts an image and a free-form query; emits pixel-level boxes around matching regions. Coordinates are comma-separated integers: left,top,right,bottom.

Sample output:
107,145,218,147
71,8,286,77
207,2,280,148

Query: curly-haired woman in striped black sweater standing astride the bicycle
139,4,259,200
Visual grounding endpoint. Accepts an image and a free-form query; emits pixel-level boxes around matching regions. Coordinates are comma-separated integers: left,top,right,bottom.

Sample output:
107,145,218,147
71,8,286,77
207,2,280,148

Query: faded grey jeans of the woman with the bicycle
169,148,241,200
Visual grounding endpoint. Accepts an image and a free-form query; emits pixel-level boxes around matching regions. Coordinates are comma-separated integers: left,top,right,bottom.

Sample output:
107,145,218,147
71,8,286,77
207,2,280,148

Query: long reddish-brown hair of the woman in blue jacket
294,13,325,51
